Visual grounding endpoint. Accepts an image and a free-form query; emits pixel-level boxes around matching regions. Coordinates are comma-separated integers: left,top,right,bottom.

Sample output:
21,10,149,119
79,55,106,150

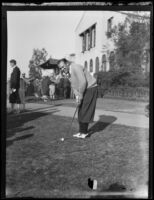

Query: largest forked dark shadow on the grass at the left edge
6,110,56,141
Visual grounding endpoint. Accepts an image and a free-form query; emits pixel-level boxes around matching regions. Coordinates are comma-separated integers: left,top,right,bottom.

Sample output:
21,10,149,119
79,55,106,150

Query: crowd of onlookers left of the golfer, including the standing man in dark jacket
8,60,71,112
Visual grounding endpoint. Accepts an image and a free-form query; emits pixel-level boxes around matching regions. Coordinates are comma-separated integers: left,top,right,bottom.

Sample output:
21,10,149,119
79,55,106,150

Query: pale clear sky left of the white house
7,11,83,78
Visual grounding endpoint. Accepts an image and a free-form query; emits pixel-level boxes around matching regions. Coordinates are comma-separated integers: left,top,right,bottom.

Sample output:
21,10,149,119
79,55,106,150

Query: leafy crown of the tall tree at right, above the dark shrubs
112,19,150,72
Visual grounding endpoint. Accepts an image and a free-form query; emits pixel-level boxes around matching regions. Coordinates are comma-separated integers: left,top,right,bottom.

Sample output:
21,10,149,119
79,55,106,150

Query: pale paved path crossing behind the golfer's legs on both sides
7,103,149,128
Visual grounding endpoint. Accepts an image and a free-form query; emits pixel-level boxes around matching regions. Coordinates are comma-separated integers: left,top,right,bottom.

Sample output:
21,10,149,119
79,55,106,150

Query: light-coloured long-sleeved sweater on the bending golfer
70,63,97,99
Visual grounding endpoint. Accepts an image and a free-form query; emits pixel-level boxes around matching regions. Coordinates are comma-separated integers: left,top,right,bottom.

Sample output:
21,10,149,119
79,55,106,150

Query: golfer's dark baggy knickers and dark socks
78,86,98,133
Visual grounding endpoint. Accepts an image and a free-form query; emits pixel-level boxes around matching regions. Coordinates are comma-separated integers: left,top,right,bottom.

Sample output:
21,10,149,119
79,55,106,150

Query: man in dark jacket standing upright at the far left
9,59,21,113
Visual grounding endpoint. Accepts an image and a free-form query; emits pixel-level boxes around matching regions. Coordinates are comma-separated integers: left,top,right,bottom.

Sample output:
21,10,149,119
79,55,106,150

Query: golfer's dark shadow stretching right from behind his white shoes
87,115,117,137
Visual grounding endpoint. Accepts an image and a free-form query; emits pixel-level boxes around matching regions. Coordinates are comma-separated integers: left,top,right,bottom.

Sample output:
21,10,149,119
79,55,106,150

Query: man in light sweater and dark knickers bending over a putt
58,58,98,138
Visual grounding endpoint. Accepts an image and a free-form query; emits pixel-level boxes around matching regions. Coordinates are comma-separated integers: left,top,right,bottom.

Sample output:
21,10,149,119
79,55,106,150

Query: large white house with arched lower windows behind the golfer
75,11,149,74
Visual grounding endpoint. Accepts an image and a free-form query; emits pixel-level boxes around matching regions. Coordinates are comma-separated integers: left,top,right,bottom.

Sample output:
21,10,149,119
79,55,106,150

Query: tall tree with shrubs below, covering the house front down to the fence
104,12,150,87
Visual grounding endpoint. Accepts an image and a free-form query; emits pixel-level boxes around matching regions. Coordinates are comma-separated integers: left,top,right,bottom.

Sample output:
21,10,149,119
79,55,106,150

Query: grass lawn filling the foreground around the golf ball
6,111,148,198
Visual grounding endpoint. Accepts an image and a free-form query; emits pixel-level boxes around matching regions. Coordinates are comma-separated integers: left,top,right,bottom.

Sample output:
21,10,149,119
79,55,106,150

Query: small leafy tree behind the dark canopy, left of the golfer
29,48,48,79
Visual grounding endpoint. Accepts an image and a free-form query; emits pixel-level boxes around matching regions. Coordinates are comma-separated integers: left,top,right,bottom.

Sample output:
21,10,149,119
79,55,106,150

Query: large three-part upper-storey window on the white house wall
80,25,96,52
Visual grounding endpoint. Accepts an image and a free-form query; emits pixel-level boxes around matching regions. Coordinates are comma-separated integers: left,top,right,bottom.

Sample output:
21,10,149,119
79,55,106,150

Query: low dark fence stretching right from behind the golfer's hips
98,87,149,101
